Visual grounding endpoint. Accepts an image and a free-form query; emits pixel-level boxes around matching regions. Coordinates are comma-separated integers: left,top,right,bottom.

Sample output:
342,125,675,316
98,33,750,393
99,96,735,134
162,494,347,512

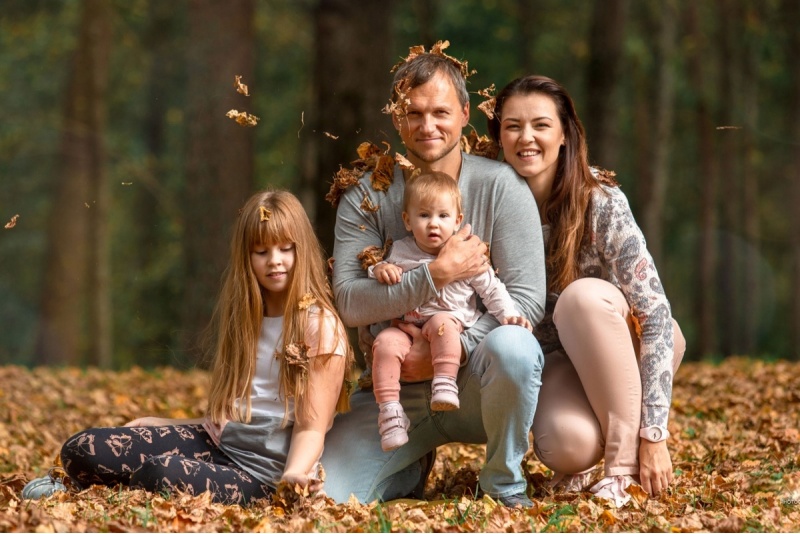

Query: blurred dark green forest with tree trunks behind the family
0,0,800,368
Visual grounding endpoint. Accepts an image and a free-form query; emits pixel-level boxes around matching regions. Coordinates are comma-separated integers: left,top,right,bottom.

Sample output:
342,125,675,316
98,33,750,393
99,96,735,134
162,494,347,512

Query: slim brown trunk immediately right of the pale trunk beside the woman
686,2,719,358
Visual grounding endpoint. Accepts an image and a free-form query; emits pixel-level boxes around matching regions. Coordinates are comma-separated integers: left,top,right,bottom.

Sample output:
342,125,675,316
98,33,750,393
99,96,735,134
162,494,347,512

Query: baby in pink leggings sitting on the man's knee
369,172,532,451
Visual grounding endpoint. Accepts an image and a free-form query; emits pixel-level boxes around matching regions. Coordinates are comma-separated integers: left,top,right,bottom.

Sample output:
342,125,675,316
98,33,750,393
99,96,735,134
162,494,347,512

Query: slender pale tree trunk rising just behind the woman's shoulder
641,0,678,265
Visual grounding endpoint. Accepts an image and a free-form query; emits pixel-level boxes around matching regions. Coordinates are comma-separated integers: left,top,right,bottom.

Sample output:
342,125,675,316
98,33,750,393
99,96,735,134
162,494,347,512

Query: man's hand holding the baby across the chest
428,224,490,290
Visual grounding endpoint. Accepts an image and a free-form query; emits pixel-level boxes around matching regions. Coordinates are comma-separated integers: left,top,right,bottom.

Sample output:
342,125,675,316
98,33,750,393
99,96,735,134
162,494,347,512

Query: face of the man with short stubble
392,73,469,167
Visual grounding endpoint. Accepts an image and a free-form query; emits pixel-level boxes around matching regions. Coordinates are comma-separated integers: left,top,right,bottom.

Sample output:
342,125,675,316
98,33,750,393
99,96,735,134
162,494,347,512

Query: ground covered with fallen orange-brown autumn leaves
0,358,800,532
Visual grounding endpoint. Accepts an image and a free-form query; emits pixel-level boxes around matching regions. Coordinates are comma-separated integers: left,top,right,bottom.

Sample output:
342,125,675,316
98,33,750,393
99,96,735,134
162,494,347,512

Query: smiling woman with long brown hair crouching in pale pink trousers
489,76,685,506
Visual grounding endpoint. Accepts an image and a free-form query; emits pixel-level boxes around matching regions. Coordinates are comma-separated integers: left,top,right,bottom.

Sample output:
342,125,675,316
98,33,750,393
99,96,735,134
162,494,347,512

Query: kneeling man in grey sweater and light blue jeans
322,48,545,507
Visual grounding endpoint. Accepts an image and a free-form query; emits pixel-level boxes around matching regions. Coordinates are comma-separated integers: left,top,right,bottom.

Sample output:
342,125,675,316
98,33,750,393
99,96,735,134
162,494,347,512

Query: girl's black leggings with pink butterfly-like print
61,425,273,505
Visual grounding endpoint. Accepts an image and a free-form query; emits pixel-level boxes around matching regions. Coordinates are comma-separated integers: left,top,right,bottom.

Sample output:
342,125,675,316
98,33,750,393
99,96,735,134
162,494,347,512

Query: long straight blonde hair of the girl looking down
208,190,353,423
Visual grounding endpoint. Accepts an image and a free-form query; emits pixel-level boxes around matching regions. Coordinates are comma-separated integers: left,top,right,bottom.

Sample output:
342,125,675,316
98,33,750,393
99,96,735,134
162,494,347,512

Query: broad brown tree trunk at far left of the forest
35,0,112,365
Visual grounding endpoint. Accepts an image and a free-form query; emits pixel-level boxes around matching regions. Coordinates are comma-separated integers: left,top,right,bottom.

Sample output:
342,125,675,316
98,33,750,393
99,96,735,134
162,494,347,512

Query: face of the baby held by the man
403,194,463,255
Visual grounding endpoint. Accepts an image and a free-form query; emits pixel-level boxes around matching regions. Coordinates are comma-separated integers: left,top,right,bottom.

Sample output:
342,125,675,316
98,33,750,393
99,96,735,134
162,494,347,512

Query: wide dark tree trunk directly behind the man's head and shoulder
301,0,401,254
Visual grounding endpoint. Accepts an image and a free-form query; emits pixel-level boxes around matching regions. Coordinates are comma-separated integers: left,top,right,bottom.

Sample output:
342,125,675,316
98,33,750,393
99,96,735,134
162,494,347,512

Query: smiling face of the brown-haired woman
500,93,564,188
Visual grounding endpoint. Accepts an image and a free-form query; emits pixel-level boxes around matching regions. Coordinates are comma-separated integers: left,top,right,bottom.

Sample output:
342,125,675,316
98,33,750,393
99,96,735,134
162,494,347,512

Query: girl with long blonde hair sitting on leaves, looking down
54,191,353,504
